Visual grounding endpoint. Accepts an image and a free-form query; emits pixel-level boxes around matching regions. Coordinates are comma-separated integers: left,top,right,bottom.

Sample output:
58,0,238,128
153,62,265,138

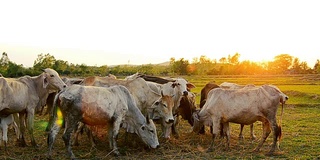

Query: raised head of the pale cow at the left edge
42,68,67,90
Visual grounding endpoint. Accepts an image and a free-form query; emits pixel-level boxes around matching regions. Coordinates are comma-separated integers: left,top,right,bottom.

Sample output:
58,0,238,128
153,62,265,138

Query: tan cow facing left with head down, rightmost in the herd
193,85,288,154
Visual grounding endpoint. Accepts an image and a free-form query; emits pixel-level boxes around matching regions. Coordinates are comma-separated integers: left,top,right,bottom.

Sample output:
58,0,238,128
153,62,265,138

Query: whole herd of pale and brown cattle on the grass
0,68,288,158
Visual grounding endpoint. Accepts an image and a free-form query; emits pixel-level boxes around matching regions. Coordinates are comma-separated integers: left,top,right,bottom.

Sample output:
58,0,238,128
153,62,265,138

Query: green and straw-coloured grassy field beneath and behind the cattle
0,75,320,160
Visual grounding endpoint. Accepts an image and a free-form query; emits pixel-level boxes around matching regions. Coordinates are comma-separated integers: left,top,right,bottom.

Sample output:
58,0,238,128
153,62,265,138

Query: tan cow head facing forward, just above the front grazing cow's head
152,92,174,123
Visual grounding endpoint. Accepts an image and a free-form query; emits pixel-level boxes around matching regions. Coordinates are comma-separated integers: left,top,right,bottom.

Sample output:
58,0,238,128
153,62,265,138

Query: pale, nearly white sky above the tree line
0,0,320,67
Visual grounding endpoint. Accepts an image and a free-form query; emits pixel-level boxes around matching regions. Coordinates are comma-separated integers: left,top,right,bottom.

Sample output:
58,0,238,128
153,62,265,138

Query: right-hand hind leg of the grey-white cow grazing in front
62,117,78,159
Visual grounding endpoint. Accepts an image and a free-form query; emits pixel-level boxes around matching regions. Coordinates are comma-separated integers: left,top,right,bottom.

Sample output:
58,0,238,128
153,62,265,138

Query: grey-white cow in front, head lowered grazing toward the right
48,85,159,159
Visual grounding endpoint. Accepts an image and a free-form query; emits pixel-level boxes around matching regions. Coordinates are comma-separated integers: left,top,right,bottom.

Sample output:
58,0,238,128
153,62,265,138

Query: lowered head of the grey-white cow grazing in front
137,116,159,148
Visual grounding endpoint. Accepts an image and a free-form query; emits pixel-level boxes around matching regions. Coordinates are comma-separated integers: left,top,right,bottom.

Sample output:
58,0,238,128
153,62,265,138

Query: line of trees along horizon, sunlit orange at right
0,52,320,77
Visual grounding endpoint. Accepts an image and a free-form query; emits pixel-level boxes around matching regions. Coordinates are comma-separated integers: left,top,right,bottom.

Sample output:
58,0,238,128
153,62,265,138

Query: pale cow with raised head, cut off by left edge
0,68,66,146
